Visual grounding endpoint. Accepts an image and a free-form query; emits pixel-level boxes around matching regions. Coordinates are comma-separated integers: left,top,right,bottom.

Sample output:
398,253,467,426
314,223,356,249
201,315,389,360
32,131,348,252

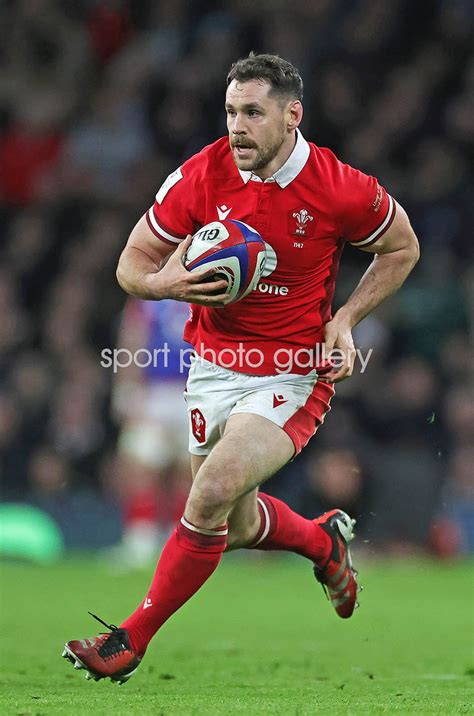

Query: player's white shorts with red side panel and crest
184,355,334,455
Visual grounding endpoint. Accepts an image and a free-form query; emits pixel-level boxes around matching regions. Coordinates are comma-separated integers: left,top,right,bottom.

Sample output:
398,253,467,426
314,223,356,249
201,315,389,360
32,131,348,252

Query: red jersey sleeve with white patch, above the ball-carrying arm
145,157,200,246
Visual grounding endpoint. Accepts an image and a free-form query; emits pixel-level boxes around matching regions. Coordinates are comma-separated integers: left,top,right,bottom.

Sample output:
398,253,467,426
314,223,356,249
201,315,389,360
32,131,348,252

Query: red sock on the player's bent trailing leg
250,492,332,564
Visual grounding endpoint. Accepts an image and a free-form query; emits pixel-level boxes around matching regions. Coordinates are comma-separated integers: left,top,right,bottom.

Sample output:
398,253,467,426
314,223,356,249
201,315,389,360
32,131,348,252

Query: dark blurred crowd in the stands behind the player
0,0,474,557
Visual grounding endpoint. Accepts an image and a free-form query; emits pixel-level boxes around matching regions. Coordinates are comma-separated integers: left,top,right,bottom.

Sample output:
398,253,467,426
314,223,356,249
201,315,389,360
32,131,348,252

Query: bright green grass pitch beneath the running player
0,555,474,716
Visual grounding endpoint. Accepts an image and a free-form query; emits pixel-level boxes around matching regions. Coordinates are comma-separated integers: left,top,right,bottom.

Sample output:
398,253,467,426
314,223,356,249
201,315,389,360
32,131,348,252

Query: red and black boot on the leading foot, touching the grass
62,612,142,684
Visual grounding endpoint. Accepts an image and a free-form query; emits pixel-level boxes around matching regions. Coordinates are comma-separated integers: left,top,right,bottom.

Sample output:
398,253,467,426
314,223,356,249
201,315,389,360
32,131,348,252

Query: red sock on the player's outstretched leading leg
121,517,228,654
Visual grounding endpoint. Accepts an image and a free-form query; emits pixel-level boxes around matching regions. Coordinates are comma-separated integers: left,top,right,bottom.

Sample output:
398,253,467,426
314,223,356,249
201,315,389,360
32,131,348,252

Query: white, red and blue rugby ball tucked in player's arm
184,219,266,303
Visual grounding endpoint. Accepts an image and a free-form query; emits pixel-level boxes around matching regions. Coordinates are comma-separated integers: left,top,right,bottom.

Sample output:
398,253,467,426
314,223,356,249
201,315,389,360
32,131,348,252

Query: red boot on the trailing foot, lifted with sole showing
314,510,362,619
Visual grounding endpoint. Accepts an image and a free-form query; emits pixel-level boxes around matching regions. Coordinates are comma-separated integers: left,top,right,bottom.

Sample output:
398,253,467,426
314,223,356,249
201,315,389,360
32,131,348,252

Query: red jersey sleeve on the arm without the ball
338,164,396,246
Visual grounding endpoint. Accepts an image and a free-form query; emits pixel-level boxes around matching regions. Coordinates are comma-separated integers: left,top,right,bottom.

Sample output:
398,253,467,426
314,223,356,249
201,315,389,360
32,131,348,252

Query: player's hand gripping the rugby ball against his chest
146,235,229,308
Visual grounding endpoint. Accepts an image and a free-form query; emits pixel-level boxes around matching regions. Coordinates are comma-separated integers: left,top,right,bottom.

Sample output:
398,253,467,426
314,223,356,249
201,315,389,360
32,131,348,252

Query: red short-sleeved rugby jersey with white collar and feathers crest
146,131,395,375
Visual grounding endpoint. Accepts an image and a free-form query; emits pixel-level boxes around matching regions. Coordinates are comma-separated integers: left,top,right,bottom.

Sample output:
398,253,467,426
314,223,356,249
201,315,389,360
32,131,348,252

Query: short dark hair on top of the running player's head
227,52,303,101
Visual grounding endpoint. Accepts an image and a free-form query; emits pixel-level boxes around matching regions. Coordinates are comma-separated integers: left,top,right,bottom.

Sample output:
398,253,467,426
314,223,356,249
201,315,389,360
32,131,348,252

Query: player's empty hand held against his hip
320,313,356,383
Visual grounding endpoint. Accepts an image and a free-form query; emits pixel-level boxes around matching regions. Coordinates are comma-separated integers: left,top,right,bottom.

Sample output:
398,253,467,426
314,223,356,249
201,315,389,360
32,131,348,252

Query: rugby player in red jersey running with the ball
63,54,419,682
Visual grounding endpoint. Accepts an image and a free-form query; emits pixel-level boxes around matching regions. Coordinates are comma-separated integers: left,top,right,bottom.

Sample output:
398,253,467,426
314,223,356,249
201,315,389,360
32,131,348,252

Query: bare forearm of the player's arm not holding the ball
336,243,418,327
